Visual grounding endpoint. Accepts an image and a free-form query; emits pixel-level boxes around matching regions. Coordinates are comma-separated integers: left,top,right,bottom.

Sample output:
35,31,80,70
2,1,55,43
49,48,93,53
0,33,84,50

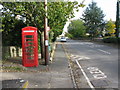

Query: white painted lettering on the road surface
87,67,107,79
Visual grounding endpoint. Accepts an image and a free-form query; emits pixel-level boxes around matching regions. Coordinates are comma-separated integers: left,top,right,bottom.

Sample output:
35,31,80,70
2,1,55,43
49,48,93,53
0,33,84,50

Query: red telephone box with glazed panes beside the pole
22,26,38,67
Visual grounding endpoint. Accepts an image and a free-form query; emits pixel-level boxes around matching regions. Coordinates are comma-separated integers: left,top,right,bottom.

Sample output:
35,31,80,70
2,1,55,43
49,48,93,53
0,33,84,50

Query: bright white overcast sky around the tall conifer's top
69,0,117,21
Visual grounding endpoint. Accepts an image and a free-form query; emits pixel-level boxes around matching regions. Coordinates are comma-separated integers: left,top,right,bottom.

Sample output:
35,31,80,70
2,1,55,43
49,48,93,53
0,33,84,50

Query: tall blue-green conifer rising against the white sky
82,2,105,38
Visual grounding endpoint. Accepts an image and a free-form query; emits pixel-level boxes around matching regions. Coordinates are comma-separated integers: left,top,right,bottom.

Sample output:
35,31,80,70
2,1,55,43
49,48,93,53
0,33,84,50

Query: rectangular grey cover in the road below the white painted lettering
91,80,108,87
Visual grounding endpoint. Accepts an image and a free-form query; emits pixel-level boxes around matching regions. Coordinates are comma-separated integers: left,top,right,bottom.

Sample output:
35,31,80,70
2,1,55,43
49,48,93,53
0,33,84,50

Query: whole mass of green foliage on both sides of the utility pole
1,2,83,45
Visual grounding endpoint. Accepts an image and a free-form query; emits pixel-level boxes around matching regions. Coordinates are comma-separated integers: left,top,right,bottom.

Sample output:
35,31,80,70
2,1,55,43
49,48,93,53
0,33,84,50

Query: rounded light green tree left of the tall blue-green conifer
68,20,86,38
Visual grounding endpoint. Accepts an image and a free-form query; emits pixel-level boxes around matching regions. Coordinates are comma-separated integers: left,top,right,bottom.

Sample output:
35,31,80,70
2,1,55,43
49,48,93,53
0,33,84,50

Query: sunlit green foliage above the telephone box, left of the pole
2,2,45,30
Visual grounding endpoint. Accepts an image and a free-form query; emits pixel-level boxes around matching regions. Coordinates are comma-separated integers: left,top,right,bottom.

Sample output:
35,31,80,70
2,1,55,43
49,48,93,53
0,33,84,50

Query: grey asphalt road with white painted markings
63,40,119,88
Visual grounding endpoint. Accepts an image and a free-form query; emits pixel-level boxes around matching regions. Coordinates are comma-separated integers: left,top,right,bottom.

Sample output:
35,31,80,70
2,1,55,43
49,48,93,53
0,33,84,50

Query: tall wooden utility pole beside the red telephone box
44,0,49,65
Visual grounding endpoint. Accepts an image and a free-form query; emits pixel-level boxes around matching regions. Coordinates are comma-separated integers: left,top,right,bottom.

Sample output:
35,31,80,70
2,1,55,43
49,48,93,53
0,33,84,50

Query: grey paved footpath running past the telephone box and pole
2,44,73,88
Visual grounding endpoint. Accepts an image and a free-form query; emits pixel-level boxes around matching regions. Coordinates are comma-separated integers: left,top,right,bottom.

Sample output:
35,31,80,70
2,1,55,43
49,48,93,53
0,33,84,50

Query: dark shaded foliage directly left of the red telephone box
2,17,25,47
